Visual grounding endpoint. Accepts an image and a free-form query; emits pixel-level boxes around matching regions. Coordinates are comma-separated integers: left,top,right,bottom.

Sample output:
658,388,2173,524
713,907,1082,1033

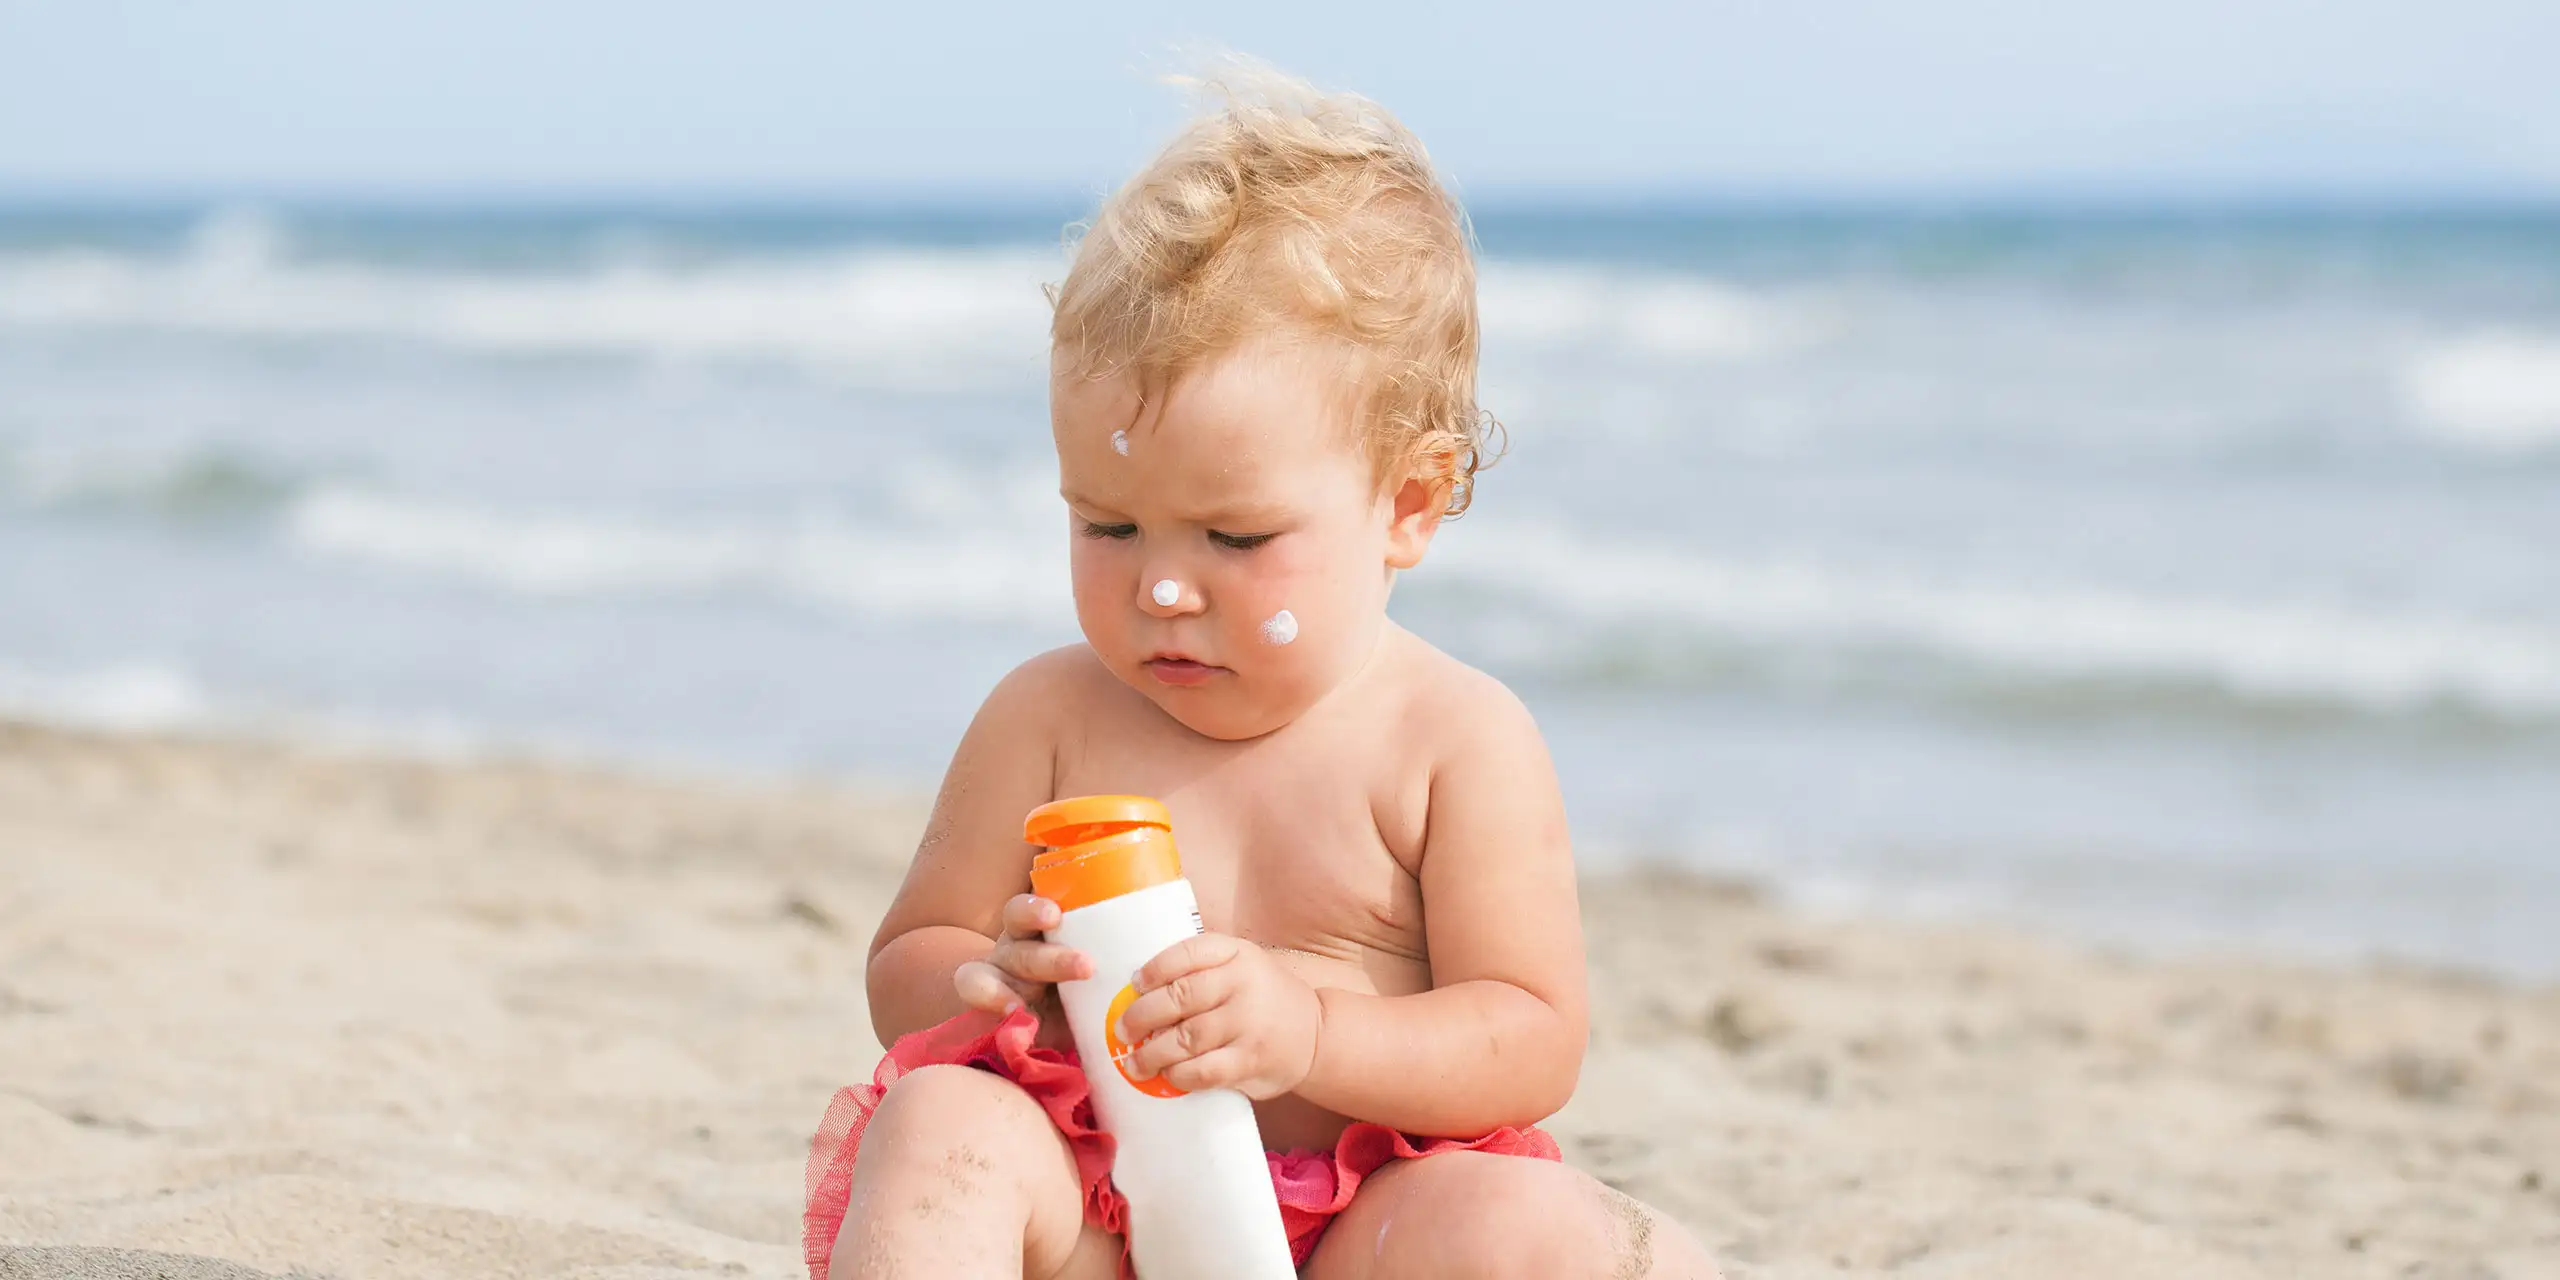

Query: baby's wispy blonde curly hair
1050,61,1500,517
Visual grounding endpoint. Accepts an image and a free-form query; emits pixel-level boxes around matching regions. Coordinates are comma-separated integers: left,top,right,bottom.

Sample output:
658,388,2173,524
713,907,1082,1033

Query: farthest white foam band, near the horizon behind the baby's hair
0,212,1815,373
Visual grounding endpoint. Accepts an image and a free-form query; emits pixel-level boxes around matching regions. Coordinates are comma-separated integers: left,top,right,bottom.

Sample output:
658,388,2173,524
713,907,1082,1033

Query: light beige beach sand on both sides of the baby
0,724,2560,1277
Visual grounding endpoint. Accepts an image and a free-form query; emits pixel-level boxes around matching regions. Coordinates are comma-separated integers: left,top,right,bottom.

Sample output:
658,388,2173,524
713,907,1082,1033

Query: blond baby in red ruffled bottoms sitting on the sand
809,67,1713,1280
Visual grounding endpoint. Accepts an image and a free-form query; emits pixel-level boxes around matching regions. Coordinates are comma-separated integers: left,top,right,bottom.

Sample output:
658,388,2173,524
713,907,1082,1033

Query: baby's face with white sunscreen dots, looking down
1050,343,1439,740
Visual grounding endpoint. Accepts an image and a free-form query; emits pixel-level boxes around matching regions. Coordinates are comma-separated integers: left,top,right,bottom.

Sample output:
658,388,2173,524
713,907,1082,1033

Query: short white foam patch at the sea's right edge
2401,330,2560,453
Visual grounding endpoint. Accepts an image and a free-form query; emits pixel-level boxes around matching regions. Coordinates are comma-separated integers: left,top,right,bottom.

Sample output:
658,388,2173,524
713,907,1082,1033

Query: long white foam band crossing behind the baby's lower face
264,486,2560,719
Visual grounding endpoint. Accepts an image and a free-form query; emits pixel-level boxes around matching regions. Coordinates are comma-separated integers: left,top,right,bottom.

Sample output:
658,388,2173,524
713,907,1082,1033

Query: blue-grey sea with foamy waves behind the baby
0,202,2560,975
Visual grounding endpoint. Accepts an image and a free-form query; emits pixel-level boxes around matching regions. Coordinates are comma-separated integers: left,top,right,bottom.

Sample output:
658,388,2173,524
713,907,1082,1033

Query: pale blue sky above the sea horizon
0,0,2560,200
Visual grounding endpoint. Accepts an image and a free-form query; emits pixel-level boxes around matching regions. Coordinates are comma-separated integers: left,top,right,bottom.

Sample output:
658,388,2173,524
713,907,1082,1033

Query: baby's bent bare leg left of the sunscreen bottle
827,1068,1119,1280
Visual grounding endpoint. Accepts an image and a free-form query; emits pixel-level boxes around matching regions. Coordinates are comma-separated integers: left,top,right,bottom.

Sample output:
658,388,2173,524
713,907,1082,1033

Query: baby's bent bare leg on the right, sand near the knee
1306,1152,1715,1280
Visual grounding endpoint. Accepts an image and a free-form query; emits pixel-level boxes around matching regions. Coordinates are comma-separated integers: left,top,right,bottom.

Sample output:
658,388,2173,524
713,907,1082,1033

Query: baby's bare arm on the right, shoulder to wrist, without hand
1298,676,1590,1137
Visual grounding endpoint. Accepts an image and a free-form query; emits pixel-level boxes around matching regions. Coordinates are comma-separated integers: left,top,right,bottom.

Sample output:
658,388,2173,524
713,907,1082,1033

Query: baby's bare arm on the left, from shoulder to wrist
865,653,1078,1044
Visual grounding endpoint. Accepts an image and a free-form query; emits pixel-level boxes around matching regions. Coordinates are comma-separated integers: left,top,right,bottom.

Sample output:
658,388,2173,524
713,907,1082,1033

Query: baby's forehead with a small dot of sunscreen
1050,343,1367,509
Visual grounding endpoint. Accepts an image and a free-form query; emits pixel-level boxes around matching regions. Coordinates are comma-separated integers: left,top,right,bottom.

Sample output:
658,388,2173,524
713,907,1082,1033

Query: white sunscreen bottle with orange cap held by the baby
1021,796,1298,1280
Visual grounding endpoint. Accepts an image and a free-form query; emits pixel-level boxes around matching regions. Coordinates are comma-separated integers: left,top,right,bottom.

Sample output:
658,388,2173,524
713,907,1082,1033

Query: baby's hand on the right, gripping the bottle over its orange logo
1121,934,1324,1098
